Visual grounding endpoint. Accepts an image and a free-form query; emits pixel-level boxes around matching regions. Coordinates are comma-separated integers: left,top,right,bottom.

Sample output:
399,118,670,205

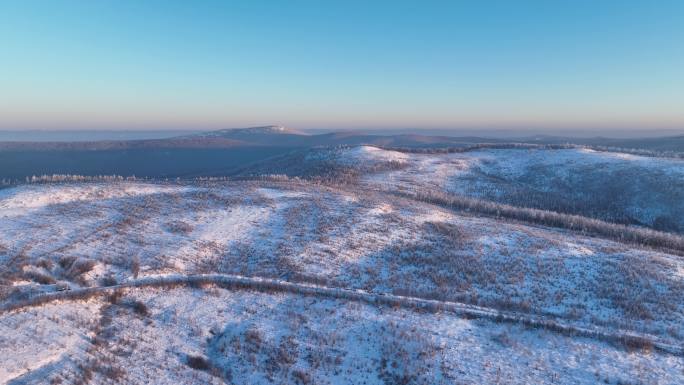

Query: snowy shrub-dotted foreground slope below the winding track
0,288,684,385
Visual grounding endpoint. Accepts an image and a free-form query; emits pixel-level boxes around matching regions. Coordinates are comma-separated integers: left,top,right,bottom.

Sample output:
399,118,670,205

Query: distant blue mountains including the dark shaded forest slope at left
0,126,684,180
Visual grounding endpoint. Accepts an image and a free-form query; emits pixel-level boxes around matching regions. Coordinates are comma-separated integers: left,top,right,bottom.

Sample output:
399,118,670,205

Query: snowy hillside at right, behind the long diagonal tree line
306,146,684,233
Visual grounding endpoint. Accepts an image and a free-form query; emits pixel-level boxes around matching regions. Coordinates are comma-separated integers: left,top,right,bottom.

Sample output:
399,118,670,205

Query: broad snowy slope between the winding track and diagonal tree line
0,182,684,338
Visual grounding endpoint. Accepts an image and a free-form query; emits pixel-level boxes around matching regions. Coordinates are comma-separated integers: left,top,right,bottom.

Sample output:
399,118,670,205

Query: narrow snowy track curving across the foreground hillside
0,274,684,356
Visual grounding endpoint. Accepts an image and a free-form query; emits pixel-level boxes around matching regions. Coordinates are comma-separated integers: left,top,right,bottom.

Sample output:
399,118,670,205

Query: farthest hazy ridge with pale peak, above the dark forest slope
0,126,684,152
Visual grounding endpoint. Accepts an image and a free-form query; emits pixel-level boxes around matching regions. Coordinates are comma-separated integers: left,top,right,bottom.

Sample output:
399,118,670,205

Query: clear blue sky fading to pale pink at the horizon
0,0,684,129
